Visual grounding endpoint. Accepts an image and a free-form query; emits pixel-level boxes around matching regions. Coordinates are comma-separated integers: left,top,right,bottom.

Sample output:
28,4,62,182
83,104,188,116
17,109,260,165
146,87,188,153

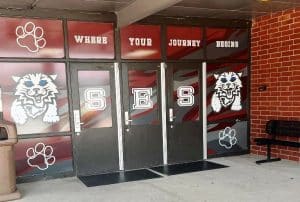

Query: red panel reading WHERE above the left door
68,21,115,59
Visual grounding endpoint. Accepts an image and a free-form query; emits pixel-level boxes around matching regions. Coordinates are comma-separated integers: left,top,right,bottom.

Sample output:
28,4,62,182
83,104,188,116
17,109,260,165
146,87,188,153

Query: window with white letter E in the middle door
128,70,159,125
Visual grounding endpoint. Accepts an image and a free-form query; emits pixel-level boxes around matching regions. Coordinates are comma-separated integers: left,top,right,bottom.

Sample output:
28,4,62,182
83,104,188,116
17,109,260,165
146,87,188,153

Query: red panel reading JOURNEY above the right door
166,26,203,60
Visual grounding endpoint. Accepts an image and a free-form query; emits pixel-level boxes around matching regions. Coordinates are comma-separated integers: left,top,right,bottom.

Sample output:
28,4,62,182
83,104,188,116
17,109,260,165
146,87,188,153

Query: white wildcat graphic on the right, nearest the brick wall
211,72,243,112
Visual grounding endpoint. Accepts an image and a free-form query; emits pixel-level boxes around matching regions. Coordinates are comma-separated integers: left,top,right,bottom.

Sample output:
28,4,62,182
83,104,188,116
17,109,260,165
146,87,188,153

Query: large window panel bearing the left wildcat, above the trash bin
0,63,70,135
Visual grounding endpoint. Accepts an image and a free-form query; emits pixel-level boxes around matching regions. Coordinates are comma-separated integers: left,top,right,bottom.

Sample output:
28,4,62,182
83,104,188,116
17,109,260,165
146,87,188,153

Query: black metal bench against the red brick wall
254,120,300,164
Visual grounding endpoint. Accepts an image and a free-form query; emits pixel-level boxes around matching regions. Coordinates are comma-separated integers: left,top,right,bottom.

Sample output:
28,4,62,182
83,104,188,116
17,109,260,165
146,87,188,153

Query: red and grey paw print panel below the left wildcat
15,136,73,177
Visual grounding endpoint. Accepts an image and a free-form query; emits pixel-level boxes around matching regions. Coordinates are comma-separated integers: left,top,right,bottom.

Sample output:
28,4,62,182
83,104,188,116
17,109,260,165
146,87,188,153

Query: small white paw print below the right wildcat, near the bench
219,127,237,149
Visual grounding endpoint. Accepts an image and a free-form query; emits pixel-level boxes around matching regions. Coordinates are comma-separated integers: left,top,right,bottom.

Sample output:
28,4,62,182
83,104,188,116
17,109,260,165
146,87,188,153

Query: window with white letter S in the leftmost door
78,71,112,128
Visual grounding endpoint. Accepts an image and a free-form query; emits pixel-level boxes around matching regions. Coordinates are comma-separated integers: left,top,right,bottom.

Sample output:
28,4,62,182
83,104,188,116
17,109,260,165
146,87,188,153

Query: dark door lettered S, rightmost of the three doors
166,63,203,164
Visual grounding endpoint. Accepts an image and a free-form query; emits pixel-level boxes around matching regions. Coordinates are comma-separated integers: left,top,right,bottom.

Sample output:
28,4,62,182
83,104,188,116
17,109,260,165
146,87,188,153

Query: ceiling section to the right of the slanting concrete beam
158,0,300,19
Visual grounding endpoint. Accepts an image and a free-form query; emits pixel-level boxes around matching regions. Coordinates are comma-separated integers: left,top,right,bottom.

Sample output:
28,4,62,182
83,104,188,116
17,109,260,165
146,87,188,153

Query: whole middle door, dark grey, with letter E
122,63,163,169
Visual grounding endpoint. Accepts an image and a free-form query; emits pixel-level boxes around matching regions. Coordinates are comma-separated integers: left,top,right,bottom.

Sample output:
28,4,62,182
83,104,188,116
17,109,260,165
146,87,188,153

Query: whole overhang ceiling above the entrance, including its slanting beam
0,0,300,25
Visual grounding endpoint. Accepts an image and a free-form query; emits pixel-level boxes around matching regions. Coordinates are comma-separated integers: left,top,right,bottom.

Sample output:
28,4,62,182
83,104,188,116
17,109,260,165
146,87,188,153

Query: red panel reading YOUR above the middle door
121,25,161,60
